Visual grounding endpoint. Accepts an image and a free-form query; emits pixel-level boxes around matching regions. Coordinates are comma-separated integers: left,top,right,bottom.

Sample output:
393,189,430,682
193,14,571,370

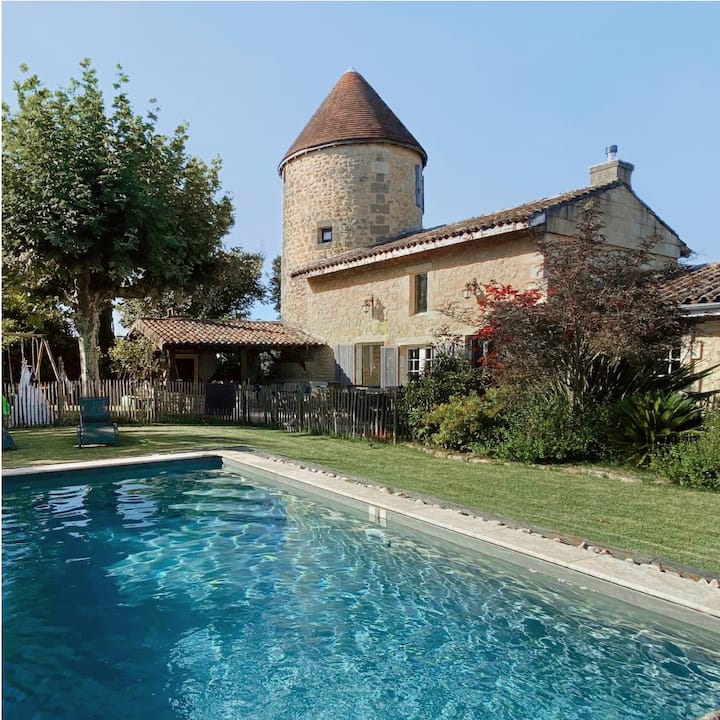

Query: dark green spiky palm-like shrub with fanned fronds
611,390,702,465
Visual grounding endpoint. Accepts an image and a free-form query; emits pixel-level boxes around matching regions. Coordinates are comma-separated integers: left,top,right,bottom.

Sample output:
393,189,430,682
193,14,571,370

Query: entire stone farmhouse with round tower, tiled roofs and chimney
134,70,720,387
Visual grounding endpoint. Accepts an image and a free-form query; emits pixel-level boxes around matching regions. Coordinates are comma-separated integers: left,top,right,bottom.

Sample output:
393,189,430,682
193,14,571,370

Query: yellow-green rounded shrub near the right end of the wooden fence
417,395,495,450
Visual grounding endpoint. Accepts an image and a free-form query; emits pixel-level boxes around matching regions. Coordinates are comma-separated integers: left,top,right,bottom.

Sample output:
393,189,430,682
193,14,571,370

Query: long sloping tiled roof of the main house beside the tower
293,180,623,276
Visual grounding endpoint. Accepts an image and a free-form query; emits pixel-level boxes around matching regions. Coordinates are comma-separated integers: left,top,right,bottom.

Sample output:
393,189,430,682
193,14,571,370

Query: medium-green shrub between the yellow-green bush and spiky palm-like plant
494,395,607,462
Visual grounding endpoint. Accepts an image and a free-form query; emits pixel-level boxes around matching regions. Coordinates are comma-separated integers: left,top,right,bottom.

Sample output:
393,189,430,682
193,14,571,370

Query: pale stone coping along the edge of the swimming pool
2,449,720,618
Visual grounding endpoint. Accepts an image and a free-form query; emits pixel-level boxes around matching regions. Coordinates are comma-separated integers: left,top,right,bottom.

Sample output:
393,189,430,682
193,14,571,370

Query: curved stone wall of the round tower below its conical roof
282,143,422,327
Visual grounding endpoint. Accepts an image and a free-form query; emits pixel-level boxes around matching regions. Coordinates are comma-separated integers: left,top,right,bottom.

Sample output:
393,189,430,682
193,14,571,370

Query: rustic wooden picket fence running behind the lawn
3,380,406,439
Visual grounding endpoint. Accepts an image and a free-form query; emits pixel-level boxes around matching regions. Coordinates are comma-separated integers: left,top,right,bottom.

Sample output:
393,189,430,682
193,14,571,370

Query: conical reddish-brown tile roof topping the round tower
279,70,427,172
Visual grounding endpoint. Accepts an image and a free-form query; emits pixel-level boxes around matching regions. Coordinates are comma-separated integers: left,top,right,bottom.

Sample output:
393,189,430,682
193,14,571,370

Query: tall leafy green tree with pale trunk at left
2,60,233,381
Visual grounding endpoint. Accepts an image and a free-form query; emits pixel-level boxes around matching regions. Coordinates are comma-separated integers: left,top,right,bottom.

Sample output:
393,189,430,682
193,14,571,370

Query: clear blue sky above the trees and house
2,1,720,319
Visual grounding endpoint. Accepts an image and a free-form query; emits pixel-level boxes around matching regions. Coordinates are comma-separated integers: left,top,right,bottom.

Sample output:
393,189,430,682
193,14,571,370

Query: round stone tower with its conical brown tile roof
278,70,427,328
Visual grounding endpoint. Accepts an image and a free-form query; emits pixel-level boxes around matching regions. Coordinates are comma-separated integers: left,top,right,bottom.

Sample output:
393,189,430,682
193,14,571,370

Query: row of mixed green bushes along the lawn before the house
401,344,720,489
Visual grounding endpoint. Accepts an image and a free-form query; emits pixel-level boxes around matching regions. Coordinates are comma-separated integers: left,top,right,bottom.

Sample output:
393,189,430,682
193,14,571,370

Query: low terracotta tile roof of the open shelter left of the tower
130,317,322,347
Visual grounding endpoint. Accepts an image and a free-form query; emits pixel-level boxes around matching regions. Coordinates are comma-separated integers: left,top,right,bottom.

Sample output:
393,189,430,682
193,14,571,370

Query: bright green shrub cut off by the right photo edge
650,410,720,490
